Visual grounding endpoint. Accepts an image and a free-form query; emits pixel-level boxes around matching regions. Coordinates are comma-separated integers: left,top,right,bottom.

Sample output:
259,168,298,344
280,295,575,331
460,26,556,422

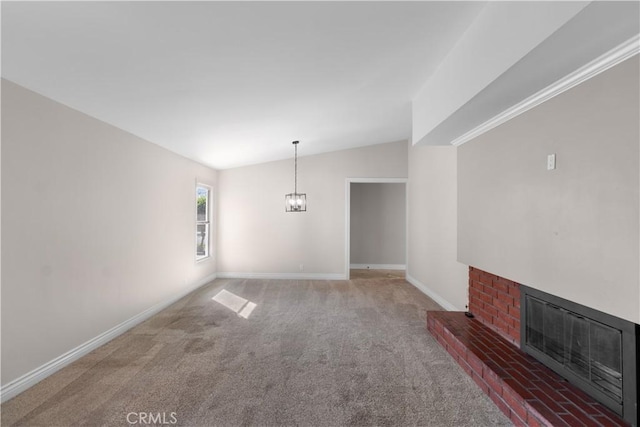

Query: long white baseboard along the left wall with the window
0,274,217,403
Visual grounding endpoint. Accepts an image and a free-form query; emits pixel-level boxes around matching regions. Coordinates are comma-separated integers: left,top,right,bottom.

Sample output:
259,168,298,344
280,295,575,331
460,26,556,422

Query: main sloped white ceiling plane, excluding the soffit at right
2,2,485,168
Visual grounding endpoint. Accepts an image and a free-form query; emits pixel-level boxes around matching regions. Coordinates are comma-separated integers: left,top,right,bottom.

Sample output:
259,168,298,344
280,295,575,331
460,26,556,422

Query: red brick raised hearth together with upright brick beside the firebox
427,268,628,427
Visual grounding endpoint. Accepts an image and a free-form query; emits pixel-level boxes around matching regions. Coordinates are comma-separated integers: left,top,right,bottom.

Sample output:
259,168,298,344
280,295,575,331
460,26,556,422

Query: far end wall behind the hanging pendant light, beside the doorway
218,141,407,277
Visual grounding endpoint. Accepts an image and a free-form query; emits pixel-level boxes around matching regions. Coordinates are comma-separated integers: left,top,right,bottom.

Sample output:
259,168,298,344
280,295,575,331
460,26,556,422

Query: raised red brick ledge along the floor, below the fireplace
427,311,628,427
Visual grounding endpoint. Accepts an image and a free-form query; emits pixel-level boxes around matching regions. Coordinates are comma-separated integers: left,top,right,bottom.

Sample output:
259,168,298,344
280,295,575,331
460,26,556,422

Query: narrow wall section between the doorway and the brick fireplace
407,146,468,310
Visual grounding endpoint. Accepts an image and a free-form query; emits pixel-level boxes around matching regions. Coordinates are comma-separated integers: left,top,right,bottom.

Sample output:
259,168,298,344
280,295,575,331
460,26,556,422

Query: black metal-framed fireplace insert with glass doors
520,286,640,425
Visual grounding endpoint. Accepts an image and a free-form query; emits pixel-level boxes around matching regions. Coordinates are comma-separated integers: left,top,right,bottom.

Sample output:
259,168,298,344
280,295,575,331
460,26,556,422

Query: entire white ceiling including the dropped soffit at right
2,1,639,169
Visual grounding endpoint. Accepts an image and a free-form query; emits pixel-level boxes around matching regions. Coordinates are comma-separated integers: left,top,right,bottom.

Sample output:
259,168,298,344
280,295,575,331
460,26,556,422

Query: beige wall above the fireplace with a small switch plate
458,56,640,323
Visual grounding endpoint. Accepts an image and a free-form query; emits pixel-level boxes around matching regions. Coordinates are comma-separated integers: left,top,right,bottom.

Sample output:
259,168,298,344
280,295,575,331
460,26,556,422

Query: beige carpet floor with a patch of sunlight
2,272,510,426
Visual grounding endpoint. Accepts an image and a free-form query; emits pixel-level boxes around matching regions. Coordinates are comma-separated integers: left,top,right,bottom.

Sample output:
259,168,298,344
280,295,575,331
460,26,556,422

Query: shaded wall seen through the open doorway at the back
350,182,407,266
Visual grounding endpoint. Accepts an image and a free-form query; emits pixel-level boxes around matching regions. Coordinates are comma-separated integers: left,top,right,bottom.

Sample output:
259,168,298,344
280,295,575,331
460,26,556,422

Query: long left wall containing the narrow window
2,80,217,385
